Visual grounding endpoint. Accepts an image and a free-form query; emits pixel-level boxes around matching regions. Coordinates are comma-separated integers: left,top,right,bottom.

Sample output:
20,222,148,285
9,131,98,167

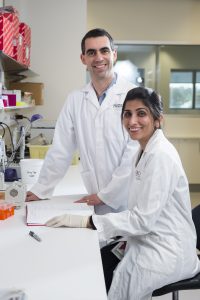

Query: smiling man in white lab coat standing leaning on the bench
27,29,137,214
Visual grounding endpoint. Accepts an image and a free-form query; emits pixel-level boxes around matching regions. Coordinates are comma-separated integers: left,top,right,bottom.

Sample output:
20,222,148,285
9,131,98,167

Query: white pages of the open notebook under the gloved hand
26,201,93,225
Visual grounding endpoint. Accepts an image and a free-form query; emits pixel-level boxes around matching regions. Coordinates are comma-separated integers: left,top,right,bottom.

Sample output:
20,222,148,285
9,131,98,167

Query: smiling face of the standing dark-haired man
81,36,117,80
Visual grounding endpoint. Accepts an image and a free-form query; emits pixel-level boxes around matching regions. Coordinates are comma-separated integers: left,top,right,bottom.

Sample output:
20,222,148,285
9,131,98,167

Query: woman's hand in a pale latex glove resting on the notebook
45,214,89,228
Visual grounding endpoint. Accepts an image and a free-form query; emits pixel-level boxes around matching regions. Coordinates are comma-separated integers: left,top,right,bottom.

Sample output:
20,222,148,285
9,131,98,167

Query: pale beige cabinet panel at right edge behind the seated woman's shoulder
170,139,200,184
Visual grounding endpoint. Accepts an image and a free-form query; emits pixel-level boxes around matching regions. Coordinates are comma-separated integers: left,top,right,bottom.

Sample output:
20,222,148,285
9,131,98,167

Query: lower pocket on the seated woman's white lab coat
137,235,179,275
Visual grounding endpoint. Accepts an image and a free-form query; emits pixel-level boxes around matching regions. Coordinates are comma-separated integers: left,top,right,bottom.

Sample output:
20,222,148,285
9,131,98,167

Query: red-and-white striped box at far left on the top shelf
0,6,19,58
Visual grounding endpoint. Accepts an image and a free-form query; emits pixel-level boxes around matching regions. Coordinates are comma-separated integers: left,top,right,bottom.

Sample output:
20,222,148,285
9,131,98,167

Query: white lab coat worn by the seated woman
93,129,200,300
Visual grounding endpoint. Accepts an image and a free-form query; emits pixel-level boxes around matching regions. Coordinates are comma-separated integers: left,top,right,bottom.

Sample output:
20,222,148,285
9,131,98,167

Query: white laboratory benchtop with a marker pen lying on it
0,166,107,300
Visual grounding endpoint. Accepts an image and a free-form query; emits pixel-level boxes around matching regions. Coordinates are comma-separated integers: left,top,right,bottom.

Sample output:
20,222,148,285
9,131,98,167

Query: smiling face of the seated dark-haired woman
123,99,159,150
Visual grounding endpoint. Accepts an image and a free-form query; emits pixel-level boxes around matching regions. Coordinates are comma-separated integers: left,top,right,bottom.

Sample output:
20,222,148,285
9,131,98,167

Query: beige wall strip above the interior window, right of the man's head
88,0,200,44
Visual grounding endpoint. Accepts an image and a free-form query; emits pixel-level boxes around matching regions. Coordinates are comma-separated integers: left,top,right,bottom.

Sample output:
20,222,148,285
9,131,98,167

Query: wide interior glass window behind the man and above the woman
116,43,200,114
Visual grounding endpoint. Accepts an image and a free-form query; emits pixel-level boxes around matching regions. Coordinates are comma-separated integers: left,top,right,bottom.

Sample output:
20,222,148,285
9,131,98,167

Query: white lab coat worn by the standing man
31,76,138,214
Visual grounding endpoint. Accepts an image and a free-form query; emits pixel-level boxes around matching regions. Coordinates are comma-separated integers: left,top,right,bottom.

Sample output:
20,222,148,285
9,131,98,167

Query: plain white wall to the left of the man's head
5,0,87,119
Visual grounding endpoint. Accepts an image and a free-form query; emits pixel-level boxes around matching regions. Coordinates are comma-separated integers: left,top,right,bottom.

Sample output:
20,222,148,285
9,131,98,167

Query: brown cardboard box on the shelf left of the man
9,82,44,105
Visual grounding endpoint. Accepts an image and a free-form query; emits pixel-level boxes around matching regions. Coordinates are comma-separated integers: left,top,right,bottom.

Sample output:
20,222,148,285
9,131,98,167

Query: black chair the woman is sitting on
152,205,200,300
